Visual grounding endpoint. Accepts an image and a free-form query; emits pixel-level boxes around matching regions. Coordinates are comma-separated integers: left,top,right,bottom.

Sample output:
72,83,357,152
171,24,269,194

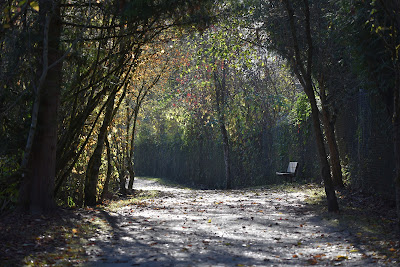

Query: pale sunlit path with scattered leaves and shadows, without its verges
86,179,386,266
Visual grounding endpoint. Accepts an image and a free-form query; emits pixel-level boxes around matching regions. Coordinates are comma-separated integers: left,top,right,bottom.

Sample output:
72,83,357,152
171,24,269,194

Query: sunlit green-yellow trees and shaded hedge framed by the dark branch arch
136,11,297,188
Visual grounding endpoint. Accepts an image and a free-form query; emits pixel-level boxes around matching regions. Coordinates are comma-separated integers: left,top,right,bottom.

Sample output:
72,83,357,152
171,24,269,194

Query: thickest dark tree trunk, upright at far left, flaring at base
19,0,62,214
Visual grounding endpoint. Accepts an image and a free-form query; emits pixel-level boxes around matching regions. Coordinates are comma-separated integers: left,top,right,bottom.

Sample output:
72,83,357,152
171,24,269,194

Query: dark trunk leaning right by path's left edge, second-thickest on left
85,92,115,206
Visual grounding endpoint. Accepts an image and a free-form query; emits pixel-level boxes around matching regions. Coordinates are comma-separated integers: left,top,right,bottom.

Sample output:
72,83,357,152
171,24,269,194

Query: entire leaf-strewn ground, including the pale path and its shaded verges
0,179,400,266
